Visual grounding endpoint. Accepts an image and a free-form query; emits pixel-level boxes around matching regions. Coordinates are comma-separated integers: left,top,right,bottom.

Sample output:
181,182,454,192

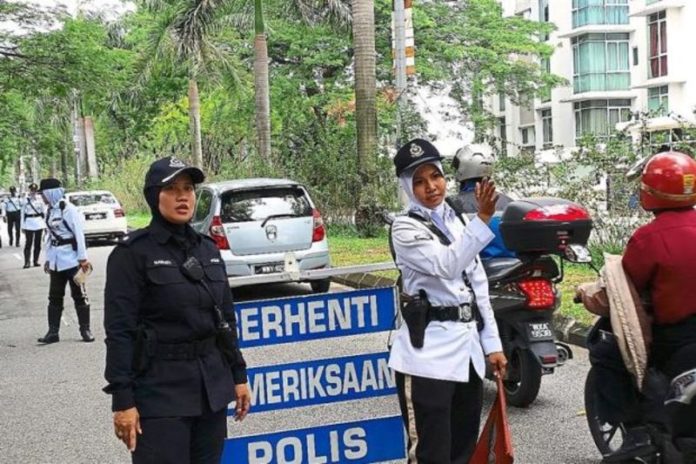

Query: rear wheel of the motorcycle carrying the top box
503,348,541,408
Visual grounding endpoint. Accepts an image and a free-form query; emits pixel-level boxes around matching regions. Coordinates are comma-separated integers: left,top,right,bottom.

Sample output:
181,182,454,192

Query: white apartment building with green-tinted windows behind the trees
489,0,696,159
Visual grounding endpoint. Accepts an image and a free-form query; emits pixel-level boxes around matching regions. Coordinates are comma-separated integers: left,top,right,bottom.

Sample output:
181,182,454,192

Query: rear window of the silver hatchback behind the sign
220,187,312,222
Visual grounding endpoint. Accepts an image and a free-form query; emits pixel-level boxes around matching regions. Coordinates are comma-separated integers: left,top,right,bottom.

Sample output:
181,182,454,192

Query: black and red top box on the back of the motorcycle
500,198,592,254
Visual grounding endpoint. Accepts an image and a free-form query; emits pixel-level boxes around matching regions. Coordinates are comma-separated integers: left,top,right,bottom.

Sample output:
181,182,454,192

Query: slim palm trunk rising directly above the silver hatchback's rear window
254,0,271,164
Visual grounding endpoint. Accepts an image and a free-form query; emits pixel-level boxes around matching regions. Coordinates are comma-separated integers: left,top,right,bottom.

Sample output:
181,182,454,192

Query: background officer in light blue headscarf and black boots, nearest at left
38,178,94,343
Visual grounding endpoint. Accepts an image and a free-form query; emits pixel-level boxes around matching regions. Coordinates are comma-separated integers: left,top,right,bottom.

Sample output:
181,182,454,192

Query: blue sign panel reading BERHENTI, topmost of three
235,287,396,348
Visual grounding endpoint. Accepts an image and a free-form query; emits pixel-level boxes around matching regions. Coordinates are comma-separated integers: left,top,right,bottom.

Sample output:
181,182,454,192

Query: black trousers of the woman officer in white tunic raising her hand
396,366,483,464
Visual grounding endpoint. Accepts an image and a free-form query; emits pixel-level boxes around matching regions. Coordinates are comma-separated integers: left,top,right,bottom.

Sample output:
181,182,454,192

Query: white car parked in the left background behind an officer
65,190,127,240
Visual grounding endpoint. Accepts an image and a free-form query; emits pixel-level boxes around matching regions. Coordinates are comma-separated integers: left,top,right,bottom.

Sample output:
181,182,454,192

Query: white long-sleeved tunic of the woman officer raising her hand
389,207,502,382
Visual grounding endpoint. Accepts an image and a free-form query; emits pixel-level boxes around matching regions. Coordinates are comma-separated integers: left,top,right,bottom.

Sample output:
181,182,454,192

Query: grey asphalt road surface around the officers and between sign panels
0,234,600,464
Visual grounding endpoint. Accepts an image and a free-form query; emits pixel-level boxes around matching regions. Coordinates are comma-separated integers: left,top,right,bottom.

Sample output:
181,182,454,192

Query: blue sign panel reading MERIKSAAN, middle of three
228,352,396,415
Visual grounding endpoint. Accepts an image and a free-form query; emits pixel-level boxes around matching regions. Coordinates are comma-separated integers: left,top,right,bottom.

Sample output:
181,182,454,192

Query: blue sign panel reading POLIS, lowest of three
222,416,406,464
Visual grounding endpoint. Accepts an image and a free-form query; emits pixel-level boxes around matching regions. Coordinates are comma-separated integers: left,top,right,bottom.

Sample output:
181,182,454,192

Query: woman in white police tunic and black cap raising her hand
389,139,507,464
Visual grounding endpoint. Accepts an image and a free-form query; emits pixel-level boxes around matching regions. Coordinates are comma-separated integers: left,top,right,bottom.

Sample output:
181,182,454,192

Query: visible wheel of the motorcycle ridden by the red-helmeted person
585,368,626,455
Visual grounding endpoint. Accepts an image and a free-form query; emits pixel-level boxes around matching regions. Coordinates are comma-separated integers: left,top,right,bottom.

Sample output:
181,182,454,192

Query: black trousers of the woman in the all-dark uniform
132,408,227,464
